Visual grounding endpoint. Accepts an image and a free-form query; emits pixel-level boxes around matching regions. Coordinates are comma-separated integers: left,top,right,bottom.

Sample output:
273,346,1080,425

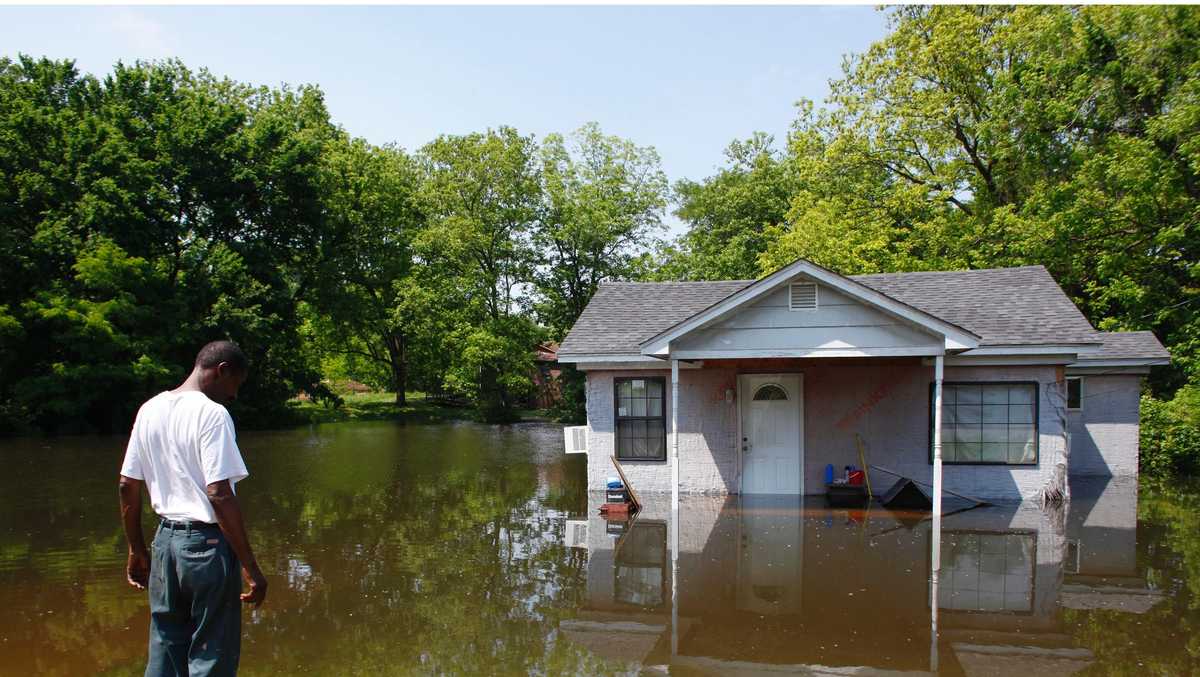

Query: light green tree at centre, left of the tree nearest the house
419,127,541,420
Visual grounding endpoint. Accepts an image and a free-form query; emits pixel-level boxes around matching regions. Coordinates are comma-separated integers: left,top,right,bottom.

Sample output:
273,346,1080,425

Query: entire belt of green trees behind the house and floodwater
0,6,1200,457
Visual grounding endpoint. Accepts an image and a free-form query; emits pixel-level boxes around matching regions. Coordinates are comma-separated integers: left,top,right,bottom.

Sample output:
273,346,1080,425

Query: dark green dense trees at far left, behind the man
0,58,334,430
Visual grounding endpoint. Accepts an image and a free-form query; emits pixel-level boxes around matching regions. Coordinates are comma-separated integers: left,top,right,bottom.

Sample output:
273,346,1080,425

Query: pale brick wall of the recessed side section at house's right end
1069,375,1141,477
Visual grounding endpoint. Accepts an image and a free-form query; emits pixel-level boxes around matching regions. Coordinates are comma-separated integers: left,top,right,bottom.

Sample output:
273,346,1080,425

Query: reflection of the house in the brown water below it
560,481,1160,676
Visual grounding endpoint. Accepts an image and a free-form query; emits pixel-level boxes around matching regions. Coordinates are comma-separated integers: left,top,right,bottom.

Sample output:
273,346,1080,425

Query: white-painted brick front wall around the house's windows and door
588,359,1066,501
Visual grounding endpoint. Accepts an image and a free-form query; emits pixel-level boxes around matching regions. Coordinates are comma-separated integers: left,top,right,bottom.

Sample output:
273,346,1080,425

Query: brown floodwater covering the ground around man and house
0,423,1200,677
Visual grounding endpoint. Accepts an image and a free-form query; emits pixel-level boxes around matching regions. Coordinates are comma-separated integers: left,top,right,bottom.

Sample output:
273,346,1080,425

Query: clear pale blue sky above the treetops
0,6,886,200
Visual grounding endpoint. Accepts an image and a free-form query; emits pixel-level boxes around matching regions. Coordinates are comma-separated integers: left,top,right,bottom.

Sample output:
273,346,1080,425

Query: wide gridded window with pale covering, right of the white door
929,383,1038,466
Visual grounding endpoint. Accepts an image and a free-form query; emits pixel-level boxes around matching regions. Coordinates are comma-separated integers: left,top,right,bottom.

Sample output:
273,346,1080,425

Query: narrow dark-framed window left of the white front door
613,377,667,461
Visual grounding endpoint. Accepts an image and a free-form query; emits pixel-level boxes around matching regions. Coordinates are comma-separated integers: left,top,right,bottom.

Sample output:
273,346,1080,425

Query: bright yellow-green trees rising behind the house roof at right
660,6,1200,395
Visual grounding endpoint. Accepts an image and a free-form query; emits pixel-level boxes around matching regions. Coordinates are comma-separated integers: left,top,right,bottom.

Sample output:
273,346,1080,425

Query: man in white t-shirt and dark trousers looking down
120,341,266,677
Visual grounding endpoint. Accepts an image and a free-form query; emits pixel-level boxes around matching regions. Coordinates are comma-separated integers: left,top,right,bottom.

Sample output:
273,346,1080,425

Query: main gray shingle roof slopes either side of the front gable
559,265,1100,355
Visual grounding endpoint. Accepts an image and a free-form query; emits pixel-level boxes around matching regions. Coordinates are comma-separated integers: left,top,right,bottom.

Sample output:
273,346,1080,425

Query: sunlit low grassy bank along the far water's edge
289,393,550,424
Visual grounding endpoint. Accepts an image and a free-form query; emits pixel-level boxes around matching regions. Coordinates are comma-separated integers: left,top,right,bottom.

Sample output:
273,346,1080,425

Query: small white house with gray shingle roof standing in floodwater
558,259,1169,502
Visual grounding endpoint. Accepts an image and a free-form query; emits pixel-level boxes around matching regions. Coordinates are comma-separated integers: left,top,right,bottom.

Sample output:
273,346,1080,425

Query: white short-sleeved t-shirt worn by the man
121,390,250,523
